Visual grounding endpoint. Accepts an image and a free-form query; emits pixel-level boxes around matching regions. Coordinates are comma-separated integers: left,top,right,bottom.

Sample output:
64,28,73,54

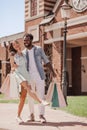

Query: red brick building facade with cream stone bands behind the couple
0,0,87,95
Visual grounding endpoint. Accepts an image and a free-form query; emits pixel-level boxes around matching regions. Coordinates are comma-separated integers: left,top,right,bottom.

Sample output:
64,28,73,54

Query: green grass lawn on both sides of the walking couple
0,94,87,117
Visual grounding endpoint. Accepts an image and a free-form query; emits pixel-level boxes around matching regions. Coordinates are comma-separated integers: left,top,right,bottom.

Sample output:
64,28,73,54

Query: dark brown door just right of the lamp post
72,47,81,95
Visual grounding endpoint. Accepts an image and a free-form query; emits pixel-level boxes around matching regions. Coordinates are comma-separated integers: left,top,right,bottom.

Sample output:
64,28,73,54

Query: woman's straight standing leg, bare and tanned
17,87,27,117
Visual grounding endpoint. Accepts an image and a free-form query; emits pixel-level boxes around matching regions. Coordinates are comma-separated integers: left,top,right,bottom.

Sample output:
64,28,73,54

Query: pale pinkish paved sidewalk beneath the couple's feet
0,103,87,130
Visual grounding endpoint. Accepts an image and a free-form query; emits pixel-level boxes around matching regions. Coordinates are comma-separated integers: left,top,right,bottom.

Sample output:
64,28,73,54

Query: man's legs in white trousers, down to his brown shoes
27,79,46,123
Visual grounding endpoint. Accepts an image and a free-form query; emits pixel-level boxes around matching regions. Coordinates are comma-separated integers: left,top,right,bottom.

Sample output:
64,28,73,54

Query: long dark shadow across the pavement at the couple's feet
20,122,87,127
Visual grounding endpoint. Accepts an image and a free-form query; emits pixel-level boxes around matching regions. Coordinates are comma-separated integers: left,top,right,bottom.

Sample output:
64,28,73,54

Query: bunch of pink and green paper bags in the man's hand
46,80,66,108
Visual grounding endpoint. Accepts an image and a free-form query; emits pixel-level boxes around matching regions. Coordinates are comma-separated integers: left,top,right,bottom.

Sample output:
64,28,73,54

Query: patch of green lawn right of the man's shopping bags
62,96,87,117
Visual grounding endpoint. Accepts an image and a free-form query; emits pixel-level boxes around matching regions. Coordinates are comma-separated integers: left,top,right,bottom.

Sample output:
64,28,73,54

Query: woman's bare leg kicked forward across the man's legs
21,81,41,103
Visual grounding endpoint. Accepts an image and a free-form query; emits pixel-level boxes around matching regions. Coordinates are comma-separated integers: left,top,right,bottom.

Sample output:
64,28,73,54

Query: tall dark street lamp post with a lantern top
61,2,71,103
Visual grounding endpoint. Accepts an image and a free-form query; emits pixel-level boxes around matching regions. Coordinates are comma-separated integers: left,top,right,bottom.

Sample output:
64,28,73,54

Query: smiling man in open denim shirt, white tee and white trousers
23,34,56,123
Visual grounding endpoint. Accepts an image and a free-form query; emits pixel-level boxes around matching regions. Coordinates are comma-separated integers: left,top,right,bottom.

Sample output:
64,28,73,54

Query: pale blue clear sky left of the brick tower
0,0,25,38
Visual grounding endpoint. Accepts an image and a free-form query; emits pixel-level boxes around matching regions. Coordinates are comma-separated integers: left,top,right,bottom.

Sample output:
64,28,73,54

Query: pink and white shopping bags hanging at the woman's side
0,73,21,99
